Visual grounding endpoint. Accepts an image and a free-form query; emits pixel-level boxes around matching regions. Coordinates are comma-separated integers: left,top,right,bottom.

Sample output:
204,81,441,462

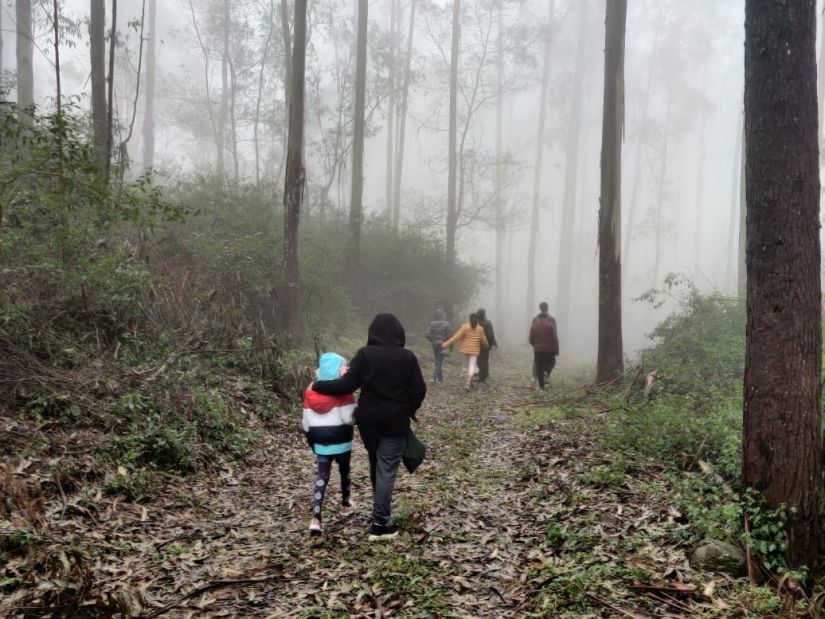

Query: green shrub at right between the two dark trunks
604,274,745,484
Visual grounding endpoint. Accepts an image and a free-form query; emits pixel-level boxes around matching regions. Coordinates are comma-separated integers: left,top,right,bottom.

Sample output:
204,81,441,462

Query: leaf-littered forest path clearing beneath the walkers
8,357,738,618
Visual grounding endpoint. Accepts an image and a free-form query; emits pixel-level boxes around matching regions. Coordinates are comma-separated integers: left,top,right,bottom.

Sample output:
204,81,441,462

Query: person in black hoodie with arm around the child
312,314,427,540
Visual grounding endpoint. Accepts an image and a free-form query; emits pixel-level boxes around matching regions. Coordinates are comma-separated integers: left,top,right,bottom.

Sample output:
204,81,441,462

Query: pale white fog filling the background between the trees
2,0,744,361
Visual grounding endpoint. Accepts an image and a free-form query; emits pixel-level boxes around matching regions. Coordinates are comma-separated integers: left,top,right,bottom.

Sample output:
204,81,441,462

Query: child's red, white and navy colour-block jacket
301,389,355,456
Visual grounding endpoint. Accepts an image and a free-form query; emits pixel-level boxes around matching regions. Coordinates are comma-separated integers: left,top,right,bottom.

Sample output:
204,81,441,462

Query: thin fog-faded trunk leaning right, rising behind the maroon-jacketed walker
525,0,555,316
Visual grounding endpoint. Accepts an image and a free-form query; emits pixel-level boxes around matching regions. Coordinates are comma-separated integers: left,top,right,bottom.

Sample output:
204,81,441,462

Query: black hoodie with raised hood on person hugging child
312,314,427,434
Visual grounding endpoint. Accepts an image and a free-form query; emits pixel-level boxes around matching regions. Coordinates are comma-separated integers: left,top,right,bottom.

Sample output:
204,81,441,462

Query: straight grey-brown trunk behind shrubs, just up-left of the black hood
344,0,368,280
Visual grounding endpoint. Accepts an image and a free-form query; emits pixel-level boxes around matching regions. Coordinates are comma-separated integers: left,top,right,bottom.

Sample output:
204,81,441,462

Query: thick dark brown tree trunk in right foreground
742,0,823,569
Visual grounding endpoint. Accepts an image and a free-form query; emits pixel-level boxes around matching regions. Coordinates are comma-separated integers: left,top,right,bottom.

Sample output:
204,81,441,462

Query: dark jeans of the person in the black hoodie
358,426,407,526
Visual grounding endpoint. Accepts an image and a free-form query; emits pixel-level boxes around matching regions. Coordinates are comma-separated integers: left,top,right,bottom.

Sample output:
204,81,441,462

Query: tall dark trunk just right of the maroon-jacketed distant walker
596,0,627,384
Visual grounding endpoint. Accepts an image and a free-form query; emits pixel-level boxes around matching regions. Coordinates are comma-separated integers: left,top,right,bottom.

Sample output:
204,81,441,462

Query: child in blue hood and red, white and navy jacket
301,352,355,535
